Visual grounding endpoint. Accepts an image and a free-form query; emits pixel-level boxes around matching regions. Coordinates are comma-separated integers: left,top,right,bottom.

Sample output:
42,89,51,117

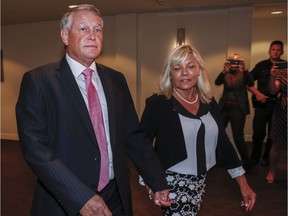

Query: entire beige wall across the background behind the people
1,7,287,139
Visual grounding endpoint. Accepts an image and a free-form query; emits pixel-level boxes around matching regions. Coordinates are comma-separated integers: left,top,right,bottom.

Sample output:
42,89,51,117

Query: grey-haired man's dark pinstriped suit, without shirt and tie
16,57,167,216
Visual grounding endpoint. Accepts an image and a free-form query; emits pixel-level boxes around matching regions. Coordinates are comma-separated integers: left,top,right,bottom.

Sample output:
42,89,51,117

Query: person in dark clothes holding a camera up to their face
215,53,254,172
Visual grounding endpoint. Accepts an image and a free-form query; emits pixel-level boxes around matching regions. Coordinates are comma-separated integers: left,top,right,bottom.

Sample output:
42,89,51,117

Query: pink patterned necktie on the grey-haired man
82,68,109,192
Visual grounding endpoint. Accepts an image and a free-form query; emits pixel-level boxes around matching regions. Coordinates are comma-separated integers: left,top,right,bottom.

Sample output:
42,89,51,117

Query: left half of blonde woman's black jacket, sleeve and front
141,94,187,169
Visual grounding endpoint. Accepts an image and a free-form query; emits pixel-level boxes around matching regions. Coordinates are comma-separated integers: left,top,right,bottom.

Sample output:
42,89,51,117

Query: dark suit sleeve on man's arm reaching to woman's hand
109,74,168,192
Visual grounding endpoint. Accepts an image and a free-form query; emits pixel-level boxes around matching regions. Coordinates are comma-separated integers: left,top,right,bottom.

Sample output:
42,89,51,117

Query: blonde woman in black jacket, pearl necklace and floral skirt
141,45,256,216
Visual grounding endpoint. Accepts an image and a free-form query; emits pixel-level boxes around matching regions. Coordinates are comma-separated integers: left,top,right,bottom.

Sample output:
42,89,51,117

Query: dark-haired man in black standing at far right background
249,40,284,167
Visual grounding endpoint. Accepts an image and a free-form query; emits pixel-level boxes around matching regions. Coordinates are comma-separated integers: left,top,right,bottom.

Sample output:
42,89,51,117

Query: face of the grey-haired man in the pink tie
61,11,103,67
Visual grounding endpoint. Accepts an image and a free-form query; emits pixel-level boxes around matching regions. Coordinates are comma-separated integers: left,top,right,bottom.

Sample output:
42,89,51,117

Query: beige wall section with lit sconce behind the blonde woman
138,7,253,113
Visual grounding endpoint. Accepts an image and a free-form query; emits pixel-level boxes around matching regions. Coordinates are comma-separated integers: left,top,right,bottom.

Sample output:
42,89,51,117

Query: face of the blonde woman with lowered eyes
171,53,200,91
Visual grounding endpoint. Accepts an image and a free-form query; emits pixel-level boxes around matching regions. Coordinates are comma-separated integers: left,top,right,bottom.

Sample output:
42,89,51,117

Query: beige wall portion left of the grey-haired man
1,22,64,139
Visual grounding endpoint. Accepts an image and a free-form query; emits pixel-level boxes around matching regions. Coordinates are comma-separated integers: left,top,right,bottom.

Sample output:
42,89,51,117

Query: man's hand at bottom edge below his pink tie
80,195,112,216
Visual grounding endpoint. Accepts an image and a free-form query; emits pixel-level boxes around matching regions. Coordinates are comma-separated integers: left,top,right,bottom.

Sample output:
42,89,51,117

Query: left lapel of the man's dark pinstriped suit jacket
58,57,97,143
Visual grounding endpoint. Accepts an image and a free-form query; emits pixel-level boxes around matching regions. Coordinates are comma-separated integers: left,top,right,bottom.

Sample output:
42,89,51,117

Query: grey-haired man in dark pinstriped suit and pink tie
16,5,170,216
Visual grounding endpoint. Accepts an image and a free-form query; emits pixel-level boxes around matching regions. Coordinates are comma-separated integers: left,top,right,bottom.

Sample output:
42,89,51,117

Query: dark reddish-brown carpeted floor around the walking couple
1,140,287,216
